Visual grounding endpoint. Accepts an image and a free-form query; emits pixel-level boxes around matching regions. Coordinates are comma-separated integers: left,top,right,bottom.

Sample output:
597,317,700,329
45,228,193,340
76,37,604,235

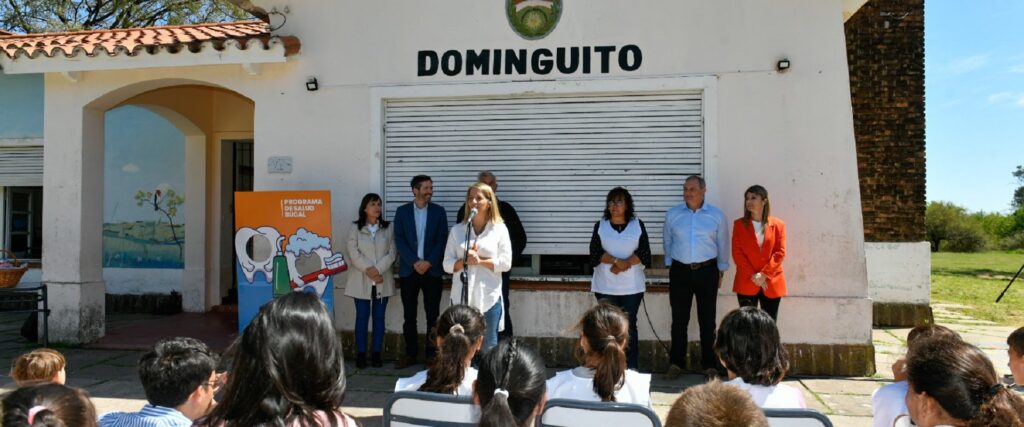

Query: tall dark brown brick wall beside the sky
846,0,926,242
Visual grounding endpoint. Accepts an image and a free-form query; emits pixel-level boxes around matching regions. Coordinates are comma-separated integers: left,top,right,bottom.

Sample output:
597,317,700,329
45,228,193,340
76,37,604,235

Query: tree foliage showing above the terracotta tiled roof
0,0,252,33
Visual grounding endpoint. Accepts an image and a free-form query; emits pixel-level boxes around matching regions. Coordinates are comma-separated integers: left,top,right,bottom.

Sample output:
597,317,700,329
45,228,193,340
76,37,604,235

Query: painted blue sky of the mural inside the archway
103,105,188,224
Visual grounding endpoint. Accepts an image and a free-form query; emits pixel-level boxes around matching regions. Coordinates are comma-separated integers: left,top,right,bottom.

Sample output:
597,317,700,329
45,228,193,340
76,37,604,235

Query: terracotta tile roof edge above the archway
0,20,301,59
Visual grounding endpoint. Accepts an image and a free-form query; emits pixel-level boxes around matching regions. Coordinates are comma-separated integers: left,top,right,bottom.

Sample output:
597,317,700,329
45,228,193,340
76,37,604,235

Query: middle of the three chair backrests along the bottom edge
540,398,662,427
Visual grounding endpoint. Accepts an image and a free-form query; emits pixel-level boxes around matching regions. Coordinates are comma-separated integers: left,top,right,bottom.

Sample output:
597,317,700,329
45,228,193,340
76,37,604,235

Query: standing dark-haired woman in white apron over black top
590,186,650,370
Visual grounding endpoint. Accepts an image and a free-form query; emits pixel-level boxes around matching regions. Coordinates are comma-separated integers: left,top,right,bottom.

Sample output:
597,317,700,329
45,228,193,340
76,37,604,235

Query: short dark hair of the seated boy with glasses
138,337,220,408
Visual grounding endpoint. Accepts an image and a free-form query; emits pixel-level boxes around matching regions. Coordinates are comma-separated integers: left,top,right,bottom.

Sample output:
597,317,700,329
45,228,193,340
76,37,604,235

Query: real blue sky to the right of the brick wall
925,0,1024,212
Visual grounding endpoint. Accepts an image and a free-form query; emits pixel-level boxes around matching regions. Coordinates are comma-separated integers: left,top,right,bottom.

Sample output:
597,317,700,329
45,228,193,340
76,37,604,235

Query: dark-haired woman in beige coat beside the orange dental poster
345,193,397,368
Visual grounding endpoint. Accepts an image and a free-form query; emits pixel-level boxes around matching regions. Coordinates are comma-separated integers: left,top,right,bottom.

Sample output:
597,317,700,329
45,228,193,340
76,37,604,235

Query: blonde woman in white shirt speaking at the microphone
444,182,512,351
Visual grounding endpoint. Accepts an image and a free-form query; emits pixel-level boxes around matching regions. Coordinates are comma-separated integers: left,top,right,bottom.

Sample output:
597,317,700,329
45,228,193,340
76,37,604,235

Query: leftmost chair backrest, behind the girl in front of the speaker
384,391,480,427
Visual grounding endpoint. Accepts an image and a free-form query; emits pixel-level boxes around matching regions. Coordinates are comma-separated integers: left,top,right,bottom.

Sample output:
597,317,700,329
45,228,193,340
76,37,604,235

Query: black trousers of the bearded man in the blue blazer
401,272,442,359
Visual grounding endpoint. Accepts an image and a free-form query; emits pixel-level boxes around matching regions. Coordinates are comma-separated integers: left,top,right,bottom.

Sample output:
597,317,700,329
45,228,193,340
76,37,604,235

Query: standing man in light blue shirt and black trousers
663,175,730,379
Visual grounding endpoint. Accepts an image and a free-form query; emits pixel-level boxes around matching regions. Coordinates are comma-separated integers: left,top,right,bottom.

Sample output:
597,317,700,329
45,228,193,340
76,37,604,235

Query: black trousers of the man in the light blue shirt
669,260,720,370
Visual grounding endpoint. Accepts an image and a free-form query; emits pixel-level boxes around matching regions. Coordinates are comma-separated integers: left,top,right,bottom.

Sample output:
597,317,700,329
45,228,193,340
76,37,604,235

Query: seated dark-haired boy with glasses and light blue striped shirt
99,337,222,427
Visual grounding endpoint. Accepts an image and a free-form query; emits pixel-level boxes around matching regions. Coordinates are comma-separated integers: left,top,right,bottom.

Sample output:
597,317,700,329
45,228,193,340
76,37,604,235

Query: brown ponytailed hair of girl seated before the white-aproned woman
577,300,630,401
